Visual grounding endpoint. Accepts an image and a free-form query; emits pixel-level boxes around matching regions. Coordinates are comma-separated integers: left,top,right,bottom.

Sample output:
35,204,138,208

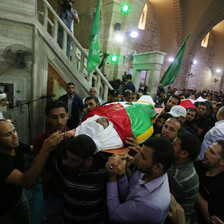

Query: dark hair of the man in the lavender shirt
143,137,174,173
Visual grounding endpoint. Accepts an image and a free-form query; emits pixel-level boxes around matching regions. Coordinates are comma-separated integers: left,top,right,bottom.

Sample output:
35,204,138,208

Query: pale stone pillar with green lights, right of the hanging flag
100,0,147,80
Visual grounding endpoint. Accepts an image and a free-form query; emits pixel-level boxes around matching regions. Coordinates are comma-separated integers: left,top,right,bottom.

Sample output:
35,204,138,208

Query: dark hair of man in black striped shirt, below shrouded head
66,134,96,159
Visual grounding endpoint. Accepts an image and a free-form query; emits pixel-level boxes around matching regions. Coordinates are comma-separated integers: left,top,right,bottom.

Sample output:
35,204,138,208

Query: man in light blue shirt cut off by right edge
198,107,224,160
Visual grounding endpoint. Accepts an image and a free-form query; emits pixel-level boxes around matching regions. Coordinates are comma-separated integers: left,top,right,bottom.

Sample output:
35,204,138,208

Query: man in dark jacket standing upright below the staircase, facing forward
59,82,85,129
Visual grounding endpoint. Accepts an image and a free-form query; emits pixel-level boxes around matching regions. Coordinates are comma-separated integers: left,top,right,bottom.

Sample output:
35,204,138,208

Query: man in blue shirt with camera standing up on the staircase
57,0,80,58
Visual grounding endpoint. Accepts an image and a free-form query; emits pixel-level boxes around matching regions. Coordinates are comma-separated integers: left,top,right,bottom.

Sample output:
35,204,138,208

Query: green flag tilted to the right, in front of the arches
160,33,191,88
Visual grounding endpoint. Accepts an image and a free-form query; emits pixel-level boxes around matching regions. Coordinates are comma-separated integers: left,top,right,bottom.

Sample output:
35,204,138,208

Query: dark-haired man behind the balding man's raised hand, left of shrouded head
33,100,69,223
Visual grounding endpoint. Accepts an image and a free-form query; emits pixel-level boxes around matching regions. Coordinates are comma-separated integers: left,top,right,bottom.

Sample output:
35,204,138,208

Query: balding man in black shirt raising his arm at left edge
0,120,64,224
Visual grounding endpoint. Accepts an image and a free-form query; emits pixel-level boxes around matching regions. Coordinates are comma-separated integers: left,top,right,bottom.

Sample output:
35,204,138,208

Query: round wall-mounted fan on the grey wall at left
0,45,33,75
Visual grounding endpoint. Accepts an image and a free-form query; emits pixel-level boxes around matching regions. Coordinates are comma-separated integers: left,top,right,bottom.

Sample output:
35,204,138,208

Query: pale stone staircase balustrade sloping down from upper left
36,0,112,101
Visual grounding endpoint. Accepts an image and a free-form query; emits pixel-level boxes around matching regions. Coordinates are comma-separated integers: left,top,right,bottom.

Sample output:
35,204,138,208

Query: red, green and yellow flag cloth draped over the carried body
83,102,156,144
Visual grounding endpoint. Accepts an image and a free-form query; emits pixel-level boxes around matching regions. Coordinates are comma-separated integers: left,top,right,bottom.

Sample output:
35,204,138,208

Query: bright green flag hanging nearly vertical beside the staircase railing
87,0,100,73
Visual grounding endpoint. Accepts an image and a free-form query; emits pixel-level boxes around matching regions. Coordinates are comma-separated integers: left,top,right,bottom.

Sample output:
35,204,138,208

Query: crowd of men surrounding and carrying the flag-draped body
0,77,224,224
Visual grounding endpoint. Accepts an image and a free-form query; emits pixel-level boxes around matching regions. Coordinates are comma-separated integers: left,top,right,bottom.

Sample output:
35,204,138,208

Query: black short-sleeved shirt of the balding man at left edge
0,143,30,216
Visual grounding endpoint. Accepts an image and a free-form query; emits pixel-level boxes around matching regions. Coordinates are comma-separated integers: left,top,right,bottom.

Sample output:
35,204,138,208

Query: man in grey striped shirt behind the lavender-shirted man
167,134,201,224
